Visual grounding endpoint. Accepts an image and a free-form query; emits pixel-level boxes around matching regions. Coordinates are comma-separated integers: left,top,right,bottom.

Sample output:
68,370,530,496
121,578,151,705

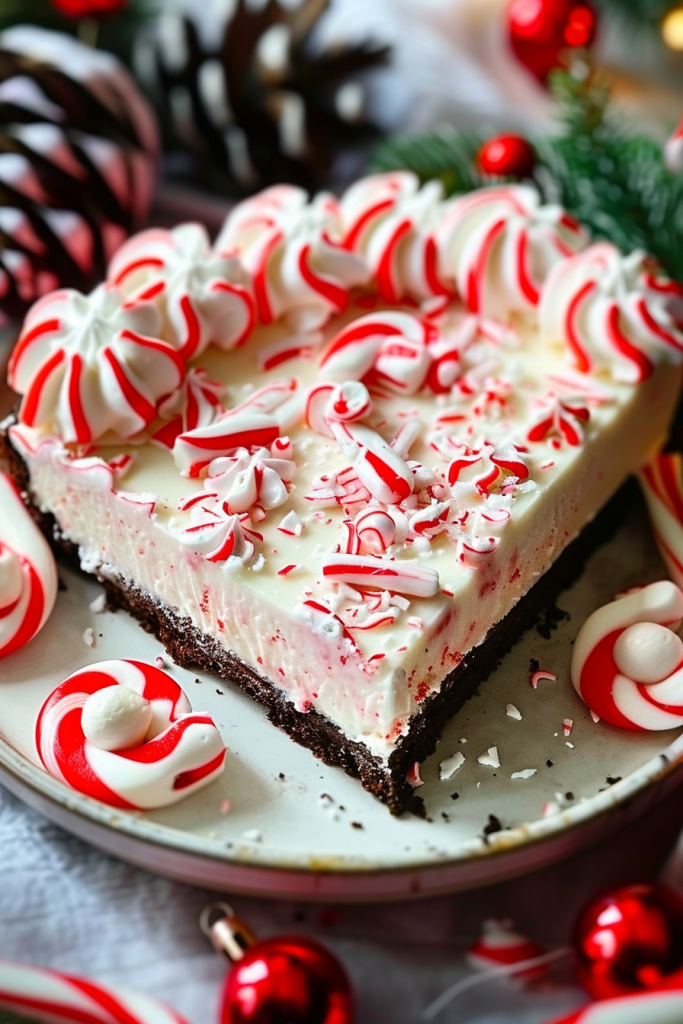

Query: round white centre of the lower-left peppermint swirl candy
81,685,153,751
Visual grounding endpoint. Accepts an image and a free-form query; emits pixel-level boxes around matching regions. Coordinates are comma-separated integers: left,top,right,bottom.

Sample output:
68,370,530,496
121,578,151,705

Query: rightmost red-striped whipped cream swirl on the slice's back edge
539,242,683,384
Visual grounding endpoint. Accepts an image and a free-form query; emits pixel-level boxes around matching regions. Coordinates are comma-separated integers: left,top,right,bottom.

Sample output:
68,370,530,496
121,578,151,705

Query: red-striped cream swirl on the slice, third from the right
339,171,450,302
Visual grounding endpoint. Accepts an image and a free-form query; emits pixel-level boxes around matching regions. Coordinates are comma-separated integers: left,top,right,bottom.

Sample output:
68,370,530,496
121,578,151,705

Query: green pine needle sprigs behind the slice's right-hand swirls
372,62,683,282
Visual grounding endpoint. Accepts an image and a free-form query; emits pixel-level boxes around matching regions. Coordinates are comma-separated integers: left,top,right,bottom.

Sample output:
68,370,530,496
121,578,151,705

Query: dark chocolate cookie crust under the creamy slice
0,424,638,815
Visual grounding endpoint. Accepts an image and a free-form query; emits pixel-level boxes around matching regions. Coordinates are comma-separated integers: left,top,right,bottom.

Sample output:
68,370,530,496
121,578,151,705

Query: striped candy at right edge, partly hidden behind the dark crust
639,452,683,589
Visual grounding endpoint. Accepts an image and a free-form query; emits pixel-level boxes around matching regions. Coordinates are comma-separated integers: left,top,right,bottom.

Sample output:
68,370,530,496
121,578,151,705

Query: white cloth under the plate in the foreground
0,774,683,1024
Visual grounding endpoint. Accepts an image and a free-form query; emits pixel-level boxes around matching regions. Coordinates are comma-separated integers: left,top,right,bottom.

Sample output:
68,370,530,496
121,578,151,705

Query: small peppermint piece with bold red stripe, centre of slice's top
330,420,414,505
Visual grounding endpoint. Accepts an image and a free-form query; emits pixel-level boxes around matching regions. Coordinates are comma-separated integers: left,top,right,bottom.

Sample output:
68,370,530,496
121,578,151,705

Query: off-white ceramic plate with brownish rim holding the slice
0,499,683,899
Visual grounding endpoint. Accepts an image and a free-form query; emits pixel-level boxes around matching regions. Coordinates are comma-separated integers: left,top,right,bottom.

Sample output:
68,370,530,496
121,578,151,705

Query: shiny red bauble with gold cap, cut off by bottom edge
220,935,353,1024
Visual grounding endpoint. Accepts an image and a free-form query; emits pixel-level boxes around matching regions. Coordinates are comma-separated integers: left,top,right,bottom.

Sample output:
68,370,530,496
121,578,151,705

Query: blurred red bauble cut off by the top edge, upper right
508,0,597,84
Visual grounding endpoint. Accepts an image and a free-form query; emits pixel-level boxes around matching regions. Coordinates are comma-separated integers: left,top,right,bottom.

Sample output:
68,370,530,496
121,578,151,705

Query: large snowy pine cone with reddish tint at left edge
0,26,158,316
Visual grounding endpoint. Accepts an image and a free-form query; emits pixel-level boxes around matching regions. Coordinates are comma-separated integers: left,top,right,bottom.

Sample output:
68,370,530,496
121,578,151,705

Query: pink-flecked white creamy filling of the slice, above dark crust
10,296,680,758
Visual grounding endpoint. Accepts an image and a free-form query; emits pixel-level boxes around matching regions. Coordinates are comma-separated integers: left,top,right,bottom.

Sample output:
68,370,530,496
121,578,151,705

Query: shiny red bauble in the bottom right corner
574,885,683,999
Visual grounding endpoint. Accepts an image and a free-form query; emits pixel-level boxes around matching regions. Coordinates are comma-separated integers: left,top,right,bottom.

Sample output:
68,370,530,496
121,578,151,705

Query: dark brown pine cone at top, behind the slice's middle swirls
135,0,389,195
